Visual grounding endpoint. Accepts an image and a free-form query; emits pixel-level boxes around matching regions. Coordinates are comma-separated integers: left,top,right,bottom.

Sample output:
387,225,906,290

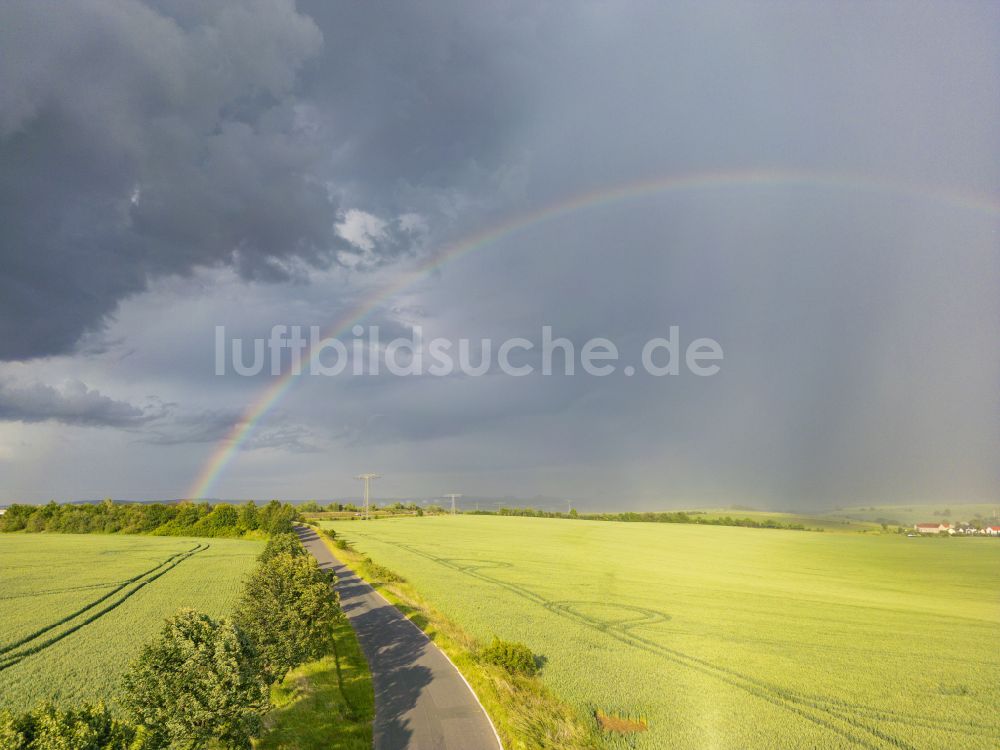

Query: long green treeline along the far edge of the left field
0,500,301,537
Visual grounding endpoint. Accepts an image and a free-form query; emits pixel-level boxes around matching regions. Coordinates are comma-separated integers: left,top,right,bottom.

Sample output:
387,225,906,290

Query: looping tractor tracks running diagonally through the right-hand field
352,533,1000,750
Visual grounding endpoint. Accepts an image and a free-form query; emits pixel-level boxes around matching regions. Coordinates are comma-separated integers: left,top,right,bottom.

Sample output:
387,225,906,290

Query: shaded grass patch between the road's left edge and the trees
254,618,375,750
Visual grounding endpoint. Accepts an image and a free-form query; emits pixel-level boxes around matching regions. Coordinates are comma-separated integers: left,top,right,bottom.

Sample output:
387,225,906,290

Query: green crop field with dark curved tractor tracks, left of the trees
0,534,263,709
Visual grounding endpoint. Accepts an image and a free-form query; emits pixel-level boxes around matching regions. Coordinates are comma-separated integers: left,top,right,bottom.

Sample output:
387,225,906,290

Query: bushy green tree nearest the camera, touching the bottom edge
123,609,268,750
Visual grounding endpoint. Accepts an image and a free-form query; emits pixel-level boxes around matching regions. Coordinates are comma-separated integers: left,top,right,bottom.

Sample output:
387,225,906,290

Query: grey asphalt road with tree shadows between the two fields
298,526,502,750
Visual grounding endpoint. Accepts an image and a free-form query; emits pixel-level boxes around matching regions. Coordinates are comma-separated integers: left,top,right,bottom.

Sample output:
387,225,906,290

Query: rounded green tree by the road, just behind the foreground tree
233,553,341,682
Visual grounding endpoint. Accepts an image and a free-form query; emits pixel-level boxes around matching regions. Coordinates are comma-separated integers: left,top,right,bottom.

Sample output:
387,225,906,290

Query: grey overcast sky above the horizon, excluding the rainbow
0,0,1000,508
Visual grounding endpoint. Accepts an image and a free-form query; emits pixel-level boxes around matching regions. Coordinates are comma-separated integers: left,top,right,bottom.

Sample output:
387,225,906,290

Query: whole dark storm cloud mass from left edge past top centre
0,0,536,360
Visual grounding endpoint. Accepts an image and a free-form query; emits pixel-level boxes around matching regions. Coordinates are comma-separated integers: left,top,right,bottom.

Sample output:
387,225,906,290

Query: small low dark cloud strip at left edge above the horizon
0,380,159,428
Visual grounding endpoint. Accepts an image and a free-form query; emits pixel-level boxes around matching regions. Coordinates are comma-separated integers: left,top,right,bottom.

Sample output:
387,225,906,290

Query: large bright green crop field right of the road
324,516,1000,750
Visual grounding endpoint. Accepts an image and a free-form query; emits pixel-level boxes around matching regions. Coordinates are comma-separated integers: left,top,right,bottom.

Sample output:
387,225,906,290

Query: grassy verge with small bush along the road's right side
320,534,602,750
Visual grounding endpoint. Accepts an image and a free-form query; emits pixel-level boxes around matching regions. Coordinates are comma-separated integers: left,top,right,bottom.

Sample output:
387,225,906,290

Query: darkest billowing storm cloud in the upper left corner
0,2,335,359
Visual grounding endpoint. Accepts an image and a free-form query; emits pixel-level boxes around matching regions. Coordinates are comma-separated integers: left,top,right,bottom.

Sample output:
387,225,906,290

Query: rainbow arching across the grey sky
186,169,1000,499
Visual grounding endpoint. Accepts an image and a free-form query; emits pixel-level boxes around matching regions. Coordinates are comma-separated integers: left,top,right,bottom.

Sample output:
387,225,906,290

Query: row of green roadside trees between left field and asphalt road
0,533,342,750
